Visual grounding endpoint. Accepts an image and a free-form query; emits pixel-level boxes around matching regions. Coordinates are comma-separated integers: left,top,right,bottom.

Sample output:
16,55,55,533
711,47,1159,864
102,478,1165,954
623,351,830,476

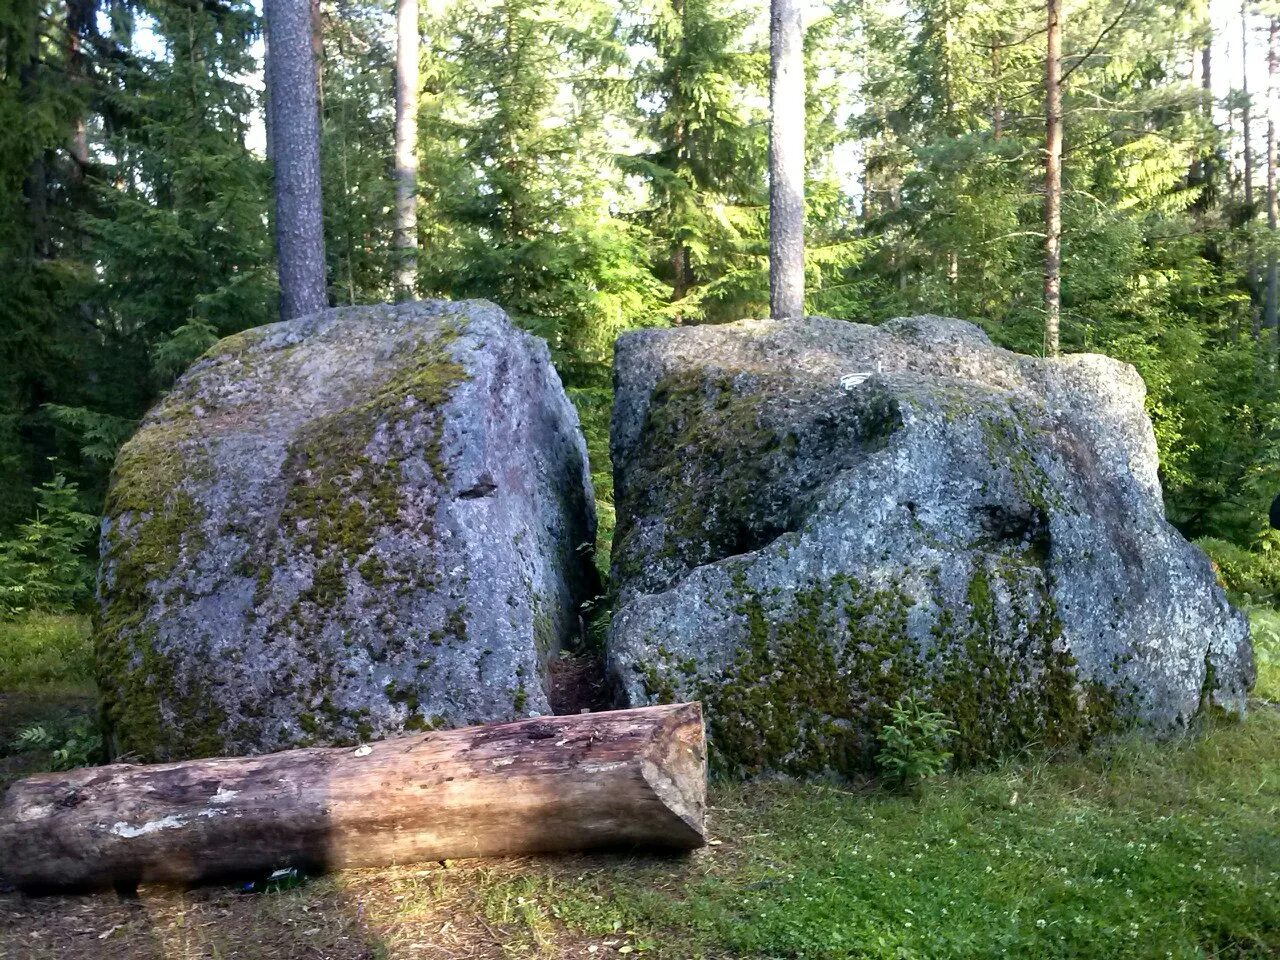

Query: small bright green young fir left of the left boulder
0,474,97,617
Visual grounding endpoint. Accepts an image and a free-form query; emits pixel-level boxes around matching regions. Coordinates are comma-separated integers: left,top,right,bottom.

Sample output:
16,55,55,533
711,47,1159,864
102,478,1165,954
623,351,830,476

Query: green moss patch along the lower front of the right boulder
643,558,1123,776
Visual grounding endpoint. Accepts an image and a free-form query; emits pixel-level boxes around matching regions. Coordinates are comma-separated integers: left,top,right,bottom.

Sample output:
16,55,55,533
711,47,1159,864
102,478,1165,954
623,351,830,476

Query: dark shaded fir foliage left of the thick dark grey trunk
0,0,275,536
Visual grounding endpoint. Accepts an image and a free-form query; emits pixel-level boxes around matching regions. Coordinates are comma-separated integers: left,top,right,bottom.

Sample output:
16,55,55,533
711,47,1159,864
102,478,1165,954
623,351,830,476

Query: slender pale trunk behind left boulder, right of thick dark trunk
396,0,419,300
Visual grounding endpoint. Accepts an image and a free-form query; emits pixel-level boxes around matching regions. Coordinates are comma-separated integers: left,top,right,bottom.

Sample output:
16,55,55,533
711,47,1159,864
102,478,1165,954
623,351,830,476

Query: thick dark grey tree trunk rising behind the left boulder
265,0,328,320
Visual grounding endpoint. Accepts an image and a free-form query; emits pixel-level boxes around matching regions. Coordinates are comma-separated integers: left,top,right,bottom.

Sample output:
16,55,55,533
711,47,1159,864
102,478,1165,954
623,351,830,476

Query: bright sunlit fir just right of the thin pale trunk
421,0,660,366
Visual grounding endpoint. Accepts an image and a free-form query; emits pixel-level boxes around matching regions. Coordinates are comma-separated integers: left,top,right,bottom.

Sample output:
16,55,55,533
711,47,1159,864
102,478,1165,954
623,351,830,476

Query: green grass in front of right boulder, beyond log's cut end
468,708,1280,960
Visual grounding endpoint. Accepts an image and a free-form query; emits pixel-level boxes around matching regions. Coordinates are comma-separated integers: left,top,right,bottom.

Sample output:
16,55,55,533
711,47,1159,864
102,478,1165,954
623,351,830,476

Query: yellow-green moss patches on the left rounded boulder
95,326,465,758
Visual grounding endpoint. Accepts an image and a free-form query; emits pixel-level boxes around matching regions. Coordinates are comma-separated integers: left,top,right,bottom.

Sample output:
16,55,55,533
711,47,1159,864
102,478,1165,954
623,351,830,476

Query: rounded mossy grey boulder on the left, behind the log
97,302,595,759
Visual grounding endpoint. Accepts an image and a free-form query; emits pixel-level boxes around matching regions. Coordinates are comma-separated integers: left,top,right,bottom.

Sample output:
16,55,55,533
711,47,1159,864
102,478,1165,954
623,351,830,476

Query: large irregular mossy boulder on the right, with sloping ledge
609,316,1253,773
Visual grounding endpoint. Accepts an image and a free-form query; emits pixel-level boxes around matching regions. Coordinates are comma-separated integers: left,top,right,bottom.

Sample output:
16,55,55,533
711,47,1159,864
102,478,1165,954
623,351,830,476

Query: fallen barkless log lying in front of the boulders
0,703,707,892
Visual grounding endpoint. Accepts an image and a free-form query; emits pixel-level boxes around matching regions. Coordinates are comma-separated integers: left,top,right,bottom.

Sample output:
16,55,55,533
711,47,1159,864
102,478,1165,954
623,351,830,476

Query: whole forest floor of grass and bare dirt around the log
0,612,1280,960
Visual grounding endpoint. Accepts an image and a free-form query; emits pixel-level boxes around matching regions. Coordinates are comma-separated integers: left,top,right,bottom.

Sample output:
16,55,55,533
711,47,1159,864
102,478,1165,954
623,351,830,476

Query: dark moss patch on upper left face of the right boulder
613,370,901,591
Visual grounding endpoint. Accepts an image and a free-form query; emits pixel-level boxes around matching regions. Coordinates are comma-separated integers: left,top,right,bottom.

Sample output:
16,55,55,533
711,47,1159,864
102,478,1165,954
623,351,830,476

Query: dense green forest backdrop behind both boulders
0,0,1280,605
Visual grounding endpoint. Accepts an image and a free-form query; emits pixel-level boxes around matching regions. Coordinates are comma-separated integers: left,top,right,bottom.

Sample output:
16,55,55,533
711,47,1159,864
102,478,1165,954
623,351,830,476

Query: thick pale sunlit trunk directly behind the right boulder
769,0,805,320
